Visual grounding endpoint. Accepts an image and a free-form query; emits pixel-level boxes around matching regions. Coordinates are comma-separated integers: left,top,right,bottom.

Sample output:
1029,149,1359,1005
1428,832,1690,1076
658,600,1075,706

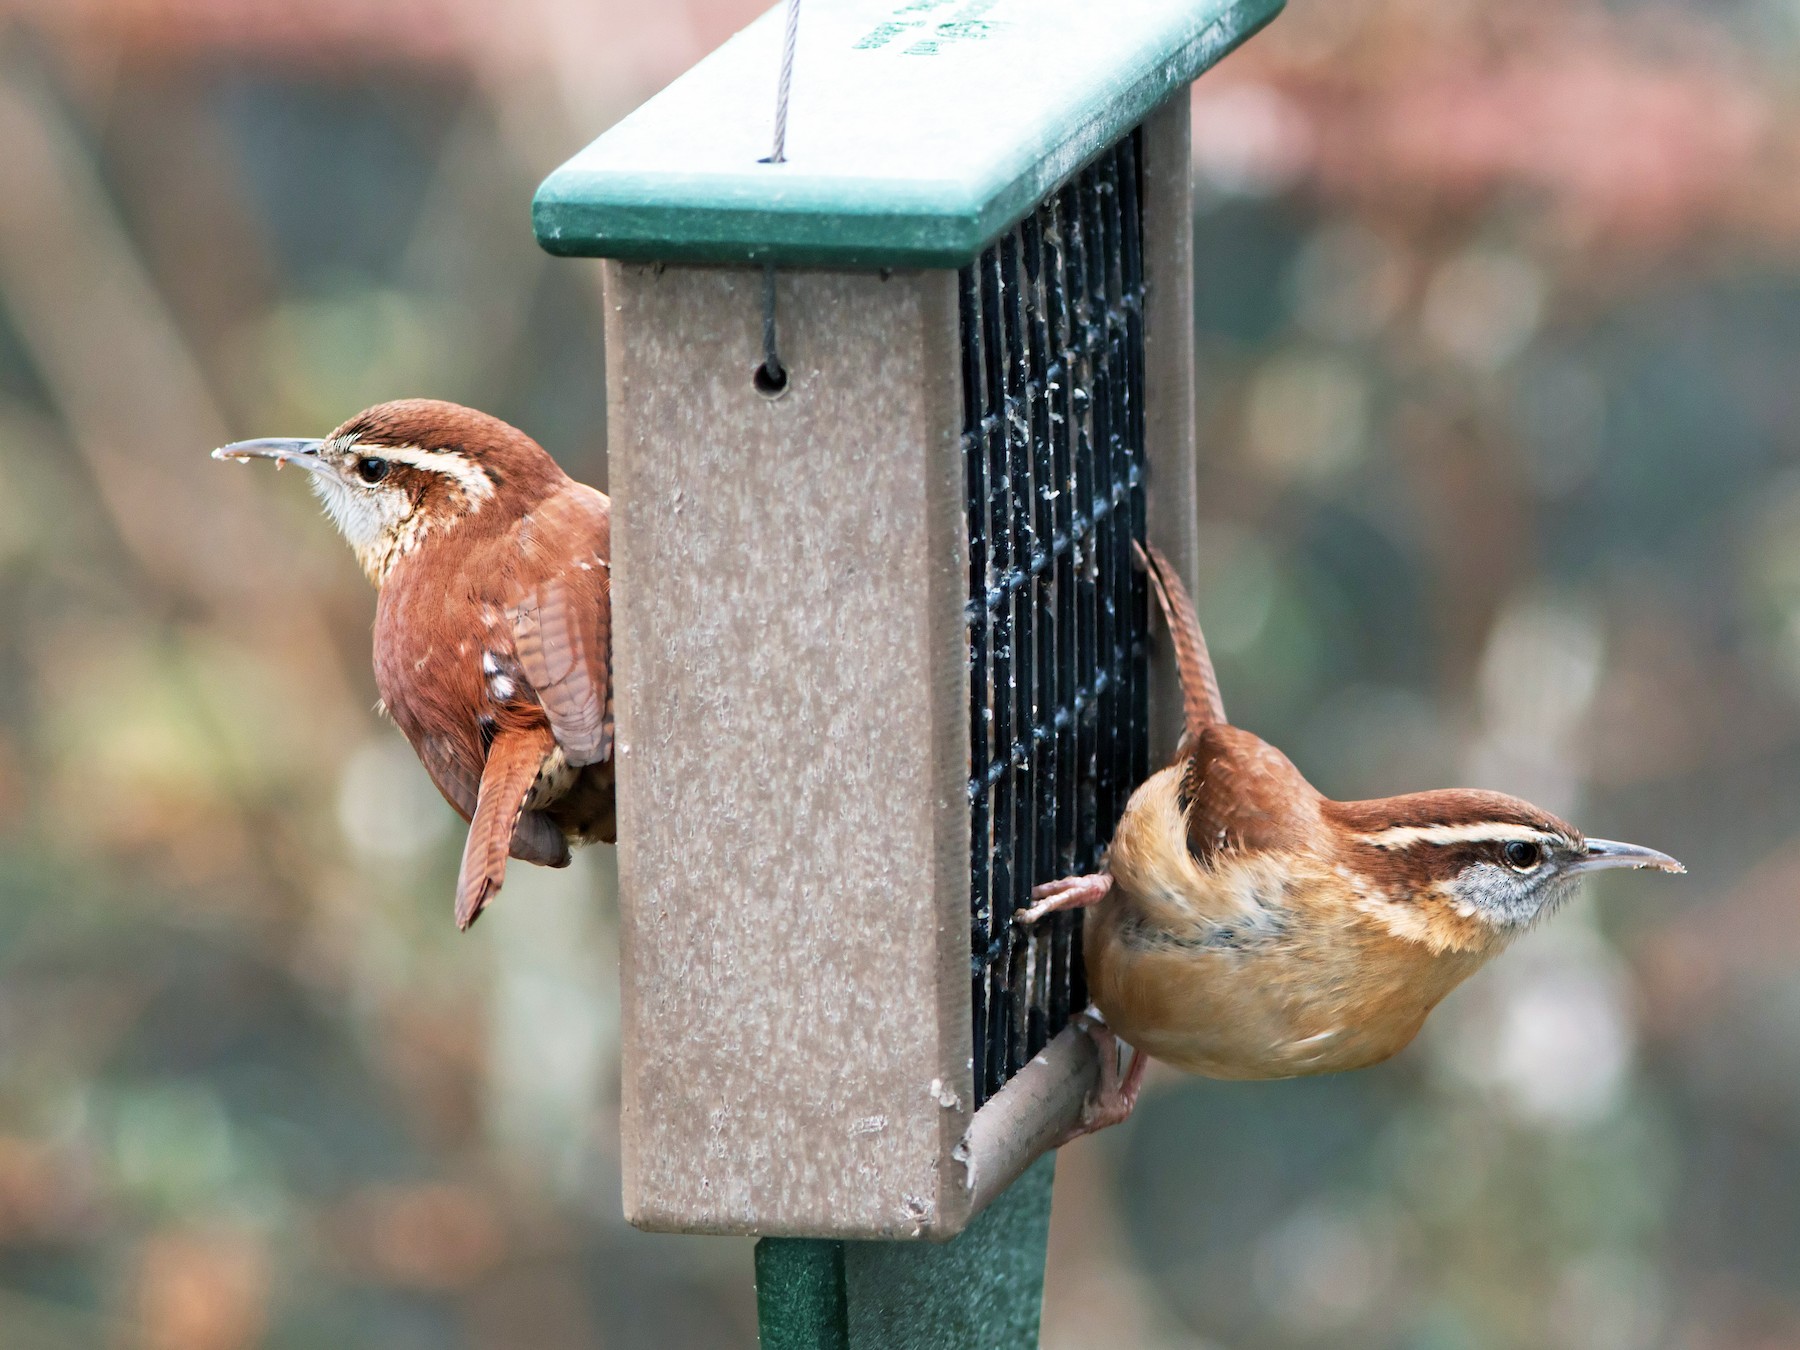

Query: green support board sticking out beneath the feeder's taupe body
756,1156,1055,1350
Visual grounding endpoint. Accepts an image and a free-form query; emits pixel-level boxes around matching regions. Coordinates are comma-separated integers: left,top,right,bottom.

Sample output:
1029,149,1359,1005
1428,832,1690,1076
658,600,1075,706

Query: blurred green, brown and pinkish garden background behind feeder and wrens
0,0,1800,1350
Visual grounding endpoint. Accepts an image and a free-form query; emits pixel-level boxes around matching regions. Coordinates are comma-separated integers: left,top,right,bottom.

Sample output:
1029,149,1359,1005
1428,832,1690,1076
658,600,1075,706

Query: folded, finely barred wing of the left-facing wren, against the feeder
508,484,612,767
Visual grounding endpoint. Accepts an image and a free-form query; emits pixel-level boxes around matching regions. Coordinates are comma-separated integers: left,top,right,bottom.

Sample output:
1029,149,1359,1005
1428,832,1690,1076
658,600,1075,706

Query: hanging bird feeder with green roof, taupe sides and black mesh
535,0,1282,1346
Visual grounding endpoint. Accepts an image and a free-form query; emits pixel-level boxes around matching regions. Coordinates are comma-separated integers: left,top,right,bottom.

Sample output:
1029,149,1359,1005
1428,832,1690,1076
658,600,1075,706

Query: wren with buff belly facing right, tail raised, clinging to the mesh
1021,549,1685,1138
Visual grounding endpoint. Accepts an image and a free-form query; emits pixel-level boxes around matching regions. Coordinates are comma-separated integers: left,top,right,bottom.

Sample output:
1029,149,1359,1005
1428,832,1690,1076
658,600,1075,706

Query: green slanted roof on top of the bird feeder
533,0,1283,266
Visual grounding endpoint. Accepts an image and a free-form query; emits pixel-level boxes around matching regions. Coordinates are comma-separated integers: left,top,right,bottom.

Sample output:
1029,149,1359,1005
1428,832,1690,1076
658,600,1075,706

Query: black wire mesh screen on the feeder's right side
961,131,1150,1105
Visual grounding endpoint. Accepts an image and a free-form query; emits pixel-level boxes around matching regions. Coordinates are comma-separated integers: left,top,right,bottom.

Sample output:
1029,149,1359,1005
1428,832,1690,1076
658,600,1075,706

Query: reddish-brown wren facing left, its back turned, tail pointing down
212,398,614,929
